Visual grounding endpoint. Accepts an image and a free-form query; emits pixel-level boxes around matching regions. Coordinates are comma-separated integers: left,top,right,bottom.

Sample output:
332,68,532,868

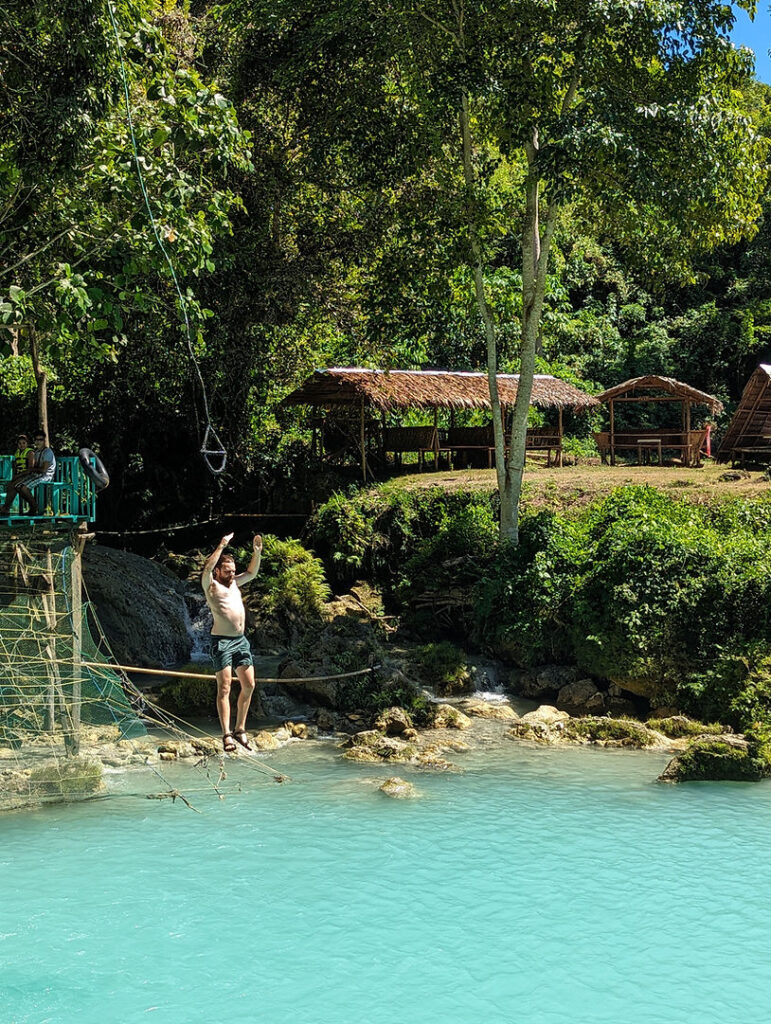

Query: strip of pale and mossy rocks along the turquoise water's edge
0,696,769,810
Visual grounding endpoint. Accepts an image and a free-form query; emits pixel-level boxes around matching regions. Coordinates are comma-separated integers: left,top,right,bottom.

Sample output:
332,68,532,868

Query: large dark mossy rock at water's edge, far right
658,735,771,782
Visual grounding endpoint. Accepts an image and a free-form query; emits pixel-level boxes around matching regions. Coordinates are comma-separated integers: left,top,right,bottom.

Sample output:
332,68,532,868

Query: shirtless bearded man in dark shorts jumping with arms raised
201,534,262,754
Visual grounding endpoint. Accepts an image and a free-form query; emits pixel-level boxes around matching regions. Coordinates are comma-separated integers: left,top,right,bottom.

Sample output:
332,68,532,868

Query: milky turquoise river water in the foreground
0,741,771,1024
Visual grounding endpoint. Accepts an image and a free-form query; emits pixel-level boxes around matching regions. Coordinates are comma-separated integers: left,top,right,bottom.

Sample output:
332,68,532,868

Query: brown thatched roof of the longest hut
283,367,597,413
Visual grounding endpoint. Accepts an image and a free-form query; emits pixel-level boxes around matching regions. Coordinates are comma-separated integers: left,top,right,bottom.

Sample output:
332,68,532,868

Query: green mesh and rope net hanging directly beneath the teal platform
0,530,145,809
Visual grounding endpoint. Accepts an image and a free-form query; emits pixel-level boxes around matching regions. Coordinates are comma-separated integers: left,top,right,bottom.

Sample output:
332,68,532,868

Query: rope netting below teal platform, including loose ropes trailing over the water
0,529,287,811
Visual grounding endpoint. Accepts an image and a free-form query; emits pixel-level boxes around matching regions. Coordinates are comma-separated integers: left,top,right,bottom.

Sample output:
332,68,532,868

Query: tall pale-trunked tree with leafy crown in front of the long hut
225,0,765,542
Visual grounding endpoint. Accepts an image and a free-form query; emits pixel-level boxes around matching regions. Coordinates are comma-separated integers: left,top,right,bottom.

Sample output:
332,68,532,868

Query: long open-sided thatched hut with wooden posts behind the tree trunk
283,367,598,480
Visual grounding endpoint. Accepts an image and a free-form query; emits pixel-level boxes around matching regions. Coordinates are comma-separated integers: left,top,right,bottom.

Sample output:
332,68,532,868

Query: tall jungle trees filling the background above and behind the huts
0,0,771,539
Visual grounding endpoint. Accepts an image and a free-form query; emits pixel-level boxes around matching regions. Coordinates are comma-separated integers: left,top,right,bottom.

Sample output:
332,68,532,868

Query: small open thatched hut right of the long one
595,375,723,466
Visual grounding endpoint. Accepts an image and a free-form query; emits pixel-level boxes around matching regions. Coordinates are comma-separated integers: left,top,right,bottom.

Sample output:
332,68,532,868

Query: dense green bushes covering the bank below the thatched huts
313,486,771,729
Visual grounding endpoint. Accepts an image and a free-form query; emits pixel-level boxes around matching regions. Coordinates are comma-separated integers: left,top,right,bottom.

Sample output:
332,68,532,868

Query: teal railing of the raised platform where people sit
0,455,96,524
